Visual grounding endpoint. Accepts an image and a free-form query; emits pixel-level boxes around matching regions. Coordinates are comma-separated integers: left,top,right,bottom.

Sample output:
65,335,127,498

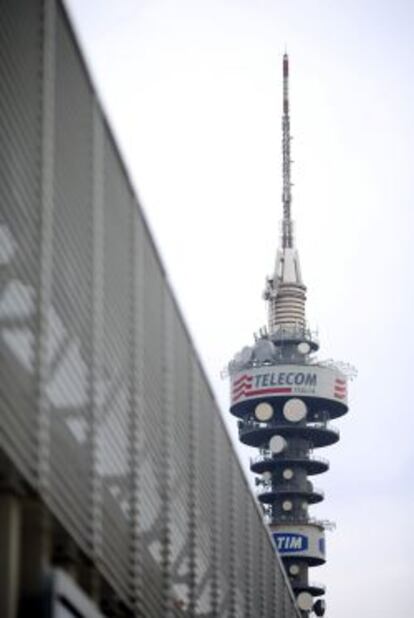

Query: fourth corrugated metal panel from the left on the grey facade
138,219,167,618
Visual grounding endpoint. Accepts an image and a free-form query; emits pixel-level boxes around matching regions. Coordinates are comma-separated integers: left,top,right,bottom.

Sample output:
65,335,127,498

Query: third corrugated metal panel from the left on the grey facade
98,134,132,598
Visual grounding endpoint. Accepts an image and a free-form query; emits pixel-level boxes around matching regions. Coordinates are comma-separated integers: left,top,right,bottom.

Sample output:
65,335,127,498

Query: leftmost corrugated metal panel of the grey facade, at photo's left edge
0,0,43,481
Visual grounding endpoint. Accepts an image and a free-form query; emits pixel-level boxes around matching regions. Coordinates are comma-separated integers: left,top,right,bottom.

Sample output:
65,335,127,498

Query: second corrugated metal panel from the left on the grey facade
46,0,93,545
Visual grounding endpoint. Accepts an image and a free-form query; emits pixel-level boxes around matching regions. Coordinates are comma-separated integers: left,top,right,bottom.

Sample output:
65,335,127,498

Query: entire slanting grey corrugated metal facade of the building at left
0,0,297,618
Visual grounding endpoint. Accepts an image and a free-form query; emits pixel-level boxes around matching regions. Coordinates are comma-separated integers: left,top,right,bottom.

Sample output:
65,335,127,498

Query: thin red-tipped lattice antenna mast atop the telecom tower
282,52,293,249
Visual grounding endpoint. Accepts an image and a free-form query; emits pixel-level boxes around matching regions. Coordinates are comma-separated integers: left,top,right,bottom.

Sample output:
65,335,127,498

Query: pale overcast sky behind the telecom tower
66,0,414,618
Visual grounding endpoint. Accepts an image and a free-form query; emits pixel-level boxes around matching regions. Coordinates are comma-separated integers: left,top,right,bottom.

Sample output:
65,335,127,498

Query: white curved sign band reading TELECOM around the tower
231,365,347,405
